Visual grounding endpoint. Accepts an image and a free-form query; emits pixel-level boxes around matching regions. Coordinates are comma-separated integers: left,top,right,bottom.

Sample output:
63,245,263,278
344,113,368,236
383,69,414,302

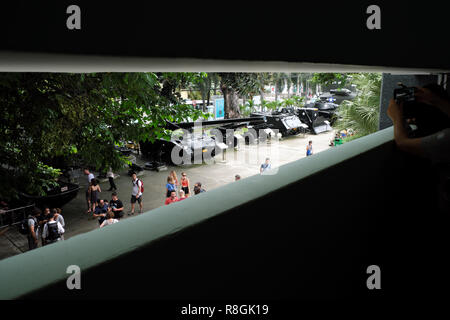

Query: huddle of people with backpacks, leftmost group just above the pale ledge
24,206,65,250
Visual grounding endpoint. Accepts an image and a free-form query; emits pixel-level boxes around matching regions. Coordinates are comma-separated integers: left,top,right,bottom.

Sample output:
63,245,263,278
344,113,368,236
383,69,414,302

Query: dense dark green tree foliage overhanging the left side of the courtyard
0,73,205,199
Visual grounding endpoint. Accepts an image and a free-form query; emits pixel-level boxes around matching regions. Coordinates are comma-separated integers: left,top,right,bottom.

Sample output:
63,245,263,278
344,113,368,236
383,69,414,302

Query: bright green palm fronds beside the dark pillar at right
335,73,381,136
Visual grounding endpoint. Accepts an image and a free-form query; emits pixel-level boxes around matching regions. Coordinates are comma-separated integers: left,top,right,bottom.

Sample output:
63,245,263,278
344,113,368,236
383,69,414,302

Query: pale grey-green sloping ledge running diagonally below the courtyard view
0,127,393,299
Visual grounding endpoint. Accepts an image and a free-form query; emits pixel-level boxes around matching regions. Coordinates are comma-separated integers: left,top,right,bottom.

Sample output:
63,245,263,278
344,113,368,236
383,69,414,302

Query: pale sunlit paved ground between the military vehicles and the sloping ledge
0,131,335,259
